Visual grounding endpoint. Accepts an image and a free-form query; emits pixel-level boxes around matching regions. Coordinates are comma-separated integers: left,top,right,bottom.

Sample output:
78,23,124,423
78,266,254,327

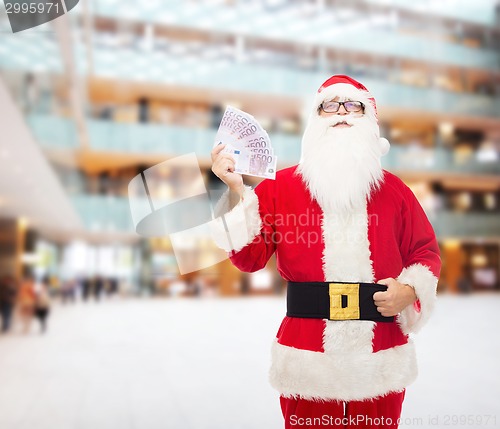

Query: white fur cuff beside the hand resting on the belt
397,264,438,334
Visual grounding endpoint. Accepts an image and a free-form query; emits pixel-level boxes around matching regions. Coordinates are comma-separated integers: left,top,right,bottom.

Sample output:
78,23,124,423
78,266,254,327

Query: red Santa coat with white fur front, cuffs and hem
214,167,440,401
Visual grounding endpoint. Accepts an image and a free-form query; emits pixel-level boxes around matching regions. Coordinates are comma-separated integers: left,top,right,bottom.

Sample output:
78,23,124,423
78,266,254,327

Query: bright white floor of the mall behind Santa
0,295,500,429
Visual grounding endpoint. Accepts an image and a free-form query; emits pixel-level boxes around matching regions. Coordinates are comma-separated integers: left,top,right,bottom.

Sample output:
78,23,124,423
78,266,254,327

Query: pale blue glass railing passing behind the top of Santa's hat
96,59,500,118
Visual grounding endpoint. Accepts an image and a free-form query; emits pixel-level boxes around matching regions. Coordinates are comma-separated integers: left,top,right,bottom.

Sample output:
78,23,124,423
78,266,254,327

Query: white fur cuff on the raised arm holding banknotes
210,186,262,252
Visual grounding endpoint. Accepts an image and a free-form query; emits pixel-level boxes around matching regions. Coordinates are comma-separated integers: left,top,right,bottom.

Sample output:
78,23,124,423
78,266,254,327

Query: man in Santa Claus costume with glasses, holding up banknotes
212,75,440,429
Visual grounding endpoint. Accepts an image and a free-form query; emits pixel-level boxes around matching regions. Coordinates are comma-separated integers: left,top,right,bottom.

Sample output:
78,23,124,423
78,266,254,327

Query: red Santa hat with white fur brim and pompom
315,74,390,155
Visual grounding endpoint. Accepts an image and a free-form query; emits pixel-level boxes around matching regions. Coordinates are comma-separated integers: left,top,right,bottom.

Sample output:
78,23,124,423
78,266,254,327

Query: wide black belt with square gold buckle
286,282,394,322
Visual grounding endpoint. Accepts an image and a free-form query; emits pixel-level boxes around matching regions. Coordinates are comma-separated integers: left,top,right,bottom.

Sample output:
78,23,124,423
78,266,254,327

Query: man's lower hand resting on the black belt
373,277,417,317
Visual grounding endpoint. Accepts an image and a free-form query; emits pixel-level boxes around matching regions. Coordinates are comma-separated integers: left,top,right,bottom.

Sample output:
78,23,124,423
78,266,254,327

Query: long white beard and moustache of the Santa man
298,114,383,213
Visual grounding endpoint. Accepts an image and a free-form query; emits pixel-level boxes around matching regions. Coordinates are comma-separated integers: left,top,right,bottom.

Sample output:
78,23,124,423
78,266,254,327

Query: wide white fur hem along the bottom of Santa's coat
269,341,417,401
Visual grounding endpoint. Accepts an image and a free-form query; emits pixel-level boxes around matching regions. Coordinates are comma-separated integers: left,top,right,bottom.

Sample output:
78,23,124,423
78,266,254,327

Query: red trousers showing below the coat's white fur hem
280,391,405,429
